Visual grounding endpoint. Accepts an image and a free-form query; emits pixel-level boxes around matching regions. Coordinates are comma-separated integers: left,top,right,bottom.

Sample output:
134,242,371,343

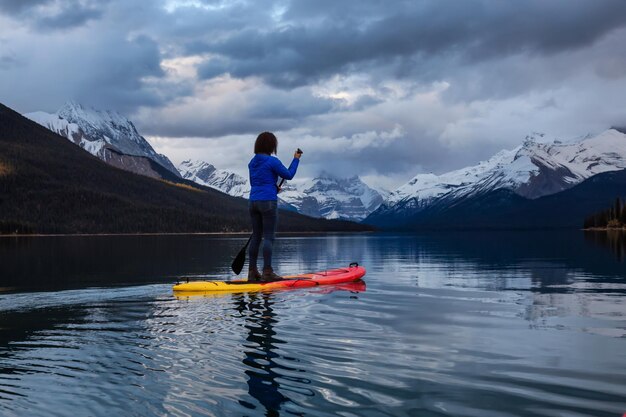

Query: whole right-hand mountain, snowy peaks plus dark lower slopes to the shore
365,129,626,228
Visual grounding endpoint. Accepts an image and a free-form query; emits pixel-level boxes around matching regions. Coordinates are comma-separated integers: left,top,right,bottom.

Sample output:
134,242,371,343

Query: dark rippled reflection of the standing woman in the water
233,293,306,416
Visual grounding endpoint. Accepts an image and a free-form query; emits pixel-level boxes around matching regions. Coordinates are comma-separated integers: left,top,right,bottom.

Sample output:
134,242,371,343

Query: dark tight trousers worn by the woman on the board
248,200,278,269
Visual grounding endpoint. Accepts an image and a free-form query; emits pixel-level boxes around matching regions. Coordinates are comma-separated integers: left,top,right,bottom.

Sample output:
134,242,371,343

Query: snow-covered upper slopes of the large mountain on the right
372,129,626,217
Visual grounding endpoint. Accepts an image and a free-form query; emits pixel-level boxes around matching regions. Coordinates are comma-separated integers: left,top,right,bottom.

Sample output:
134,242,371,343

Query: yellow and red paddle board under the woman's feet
173,263,365,292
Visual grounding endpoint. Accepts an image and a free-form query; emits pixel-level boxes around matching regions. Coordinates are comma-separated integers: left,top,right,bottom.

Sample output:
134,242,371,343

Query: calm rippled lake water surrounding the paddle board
0,232,626,417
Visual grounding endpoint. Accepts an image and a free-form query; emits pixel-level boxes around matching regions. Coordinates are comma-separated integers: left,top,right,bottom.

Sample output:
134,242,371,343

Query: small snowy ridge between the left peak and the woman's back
178,159,250,197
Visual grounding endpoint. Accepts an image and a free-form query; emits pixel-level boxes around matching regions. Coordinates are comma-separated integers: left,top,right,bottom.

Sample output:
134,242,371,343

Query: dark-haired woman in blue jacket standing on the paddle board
248,132,302,281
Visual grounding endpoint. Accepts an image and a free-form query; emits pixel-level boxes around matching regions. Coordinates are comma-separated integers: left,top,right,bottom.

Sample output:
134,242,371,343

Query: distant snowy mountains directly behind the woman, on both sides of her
178,160,383,221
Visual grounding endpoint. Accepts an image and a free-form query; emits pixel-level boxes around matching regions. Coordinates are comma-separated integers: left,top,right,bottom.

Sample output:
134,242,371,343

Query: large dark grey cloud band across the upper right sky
194,0,626,88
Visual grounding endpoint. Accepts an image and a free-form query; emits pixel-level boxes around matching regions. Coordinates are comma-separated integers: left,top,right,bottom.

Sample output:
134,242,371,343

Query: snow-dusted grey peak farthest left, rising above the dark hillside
24,102,179,178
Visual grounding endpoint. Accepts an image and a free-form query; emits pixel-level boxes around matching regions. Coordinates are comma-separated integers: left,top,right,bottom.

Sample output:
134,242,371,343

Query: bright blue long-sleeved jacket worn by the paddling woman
248,153,300,201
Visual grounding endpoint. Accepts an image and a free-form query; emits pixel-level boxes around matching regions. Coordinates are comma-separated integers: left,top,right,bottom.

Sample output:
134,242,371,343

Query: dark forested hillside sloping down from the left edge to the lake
0,105,365,233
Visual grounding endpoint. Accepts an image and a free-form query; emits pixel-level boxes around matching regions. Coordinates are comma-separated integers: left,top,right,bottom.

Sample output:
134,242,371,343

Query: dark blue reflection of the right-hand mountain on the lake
352,231,625,292
